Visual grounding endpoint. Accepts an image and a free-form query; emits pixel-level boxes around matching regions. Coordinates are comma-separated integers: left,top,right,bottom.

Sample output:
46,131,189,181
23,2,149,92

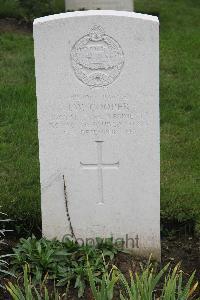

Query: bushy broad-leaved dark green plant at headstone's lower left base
11,236,117,297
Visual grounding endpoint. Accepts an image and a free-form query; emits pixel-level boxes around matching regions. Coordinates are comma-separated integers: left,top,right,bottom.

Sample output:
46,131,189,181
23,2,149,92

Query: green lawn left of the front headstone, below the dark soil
0,33,40,229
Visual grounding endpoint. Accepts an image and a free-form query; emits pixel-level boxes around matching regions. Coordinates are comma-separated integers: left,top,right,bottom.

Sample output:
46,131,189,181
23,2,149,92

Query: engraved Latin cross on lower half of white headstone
80,141,119,204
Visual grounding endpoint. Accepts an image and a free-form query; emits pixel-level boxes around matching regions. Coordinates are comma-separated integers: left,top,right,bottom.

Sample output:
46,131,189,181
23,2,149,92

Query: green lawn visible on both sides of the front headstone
0,0,200,232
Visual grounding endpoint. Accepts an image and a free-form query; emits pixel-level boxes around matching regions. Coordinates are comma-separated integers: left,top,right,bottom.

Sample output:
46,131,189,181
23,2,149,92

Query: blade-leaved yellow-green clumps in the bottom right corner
120,264,198,300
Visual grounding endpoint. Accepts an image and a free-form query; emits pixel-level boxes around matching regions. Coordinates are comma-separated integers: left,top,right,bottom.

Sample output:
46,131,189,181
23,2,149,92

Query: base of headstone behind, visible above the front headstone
65,0,133,11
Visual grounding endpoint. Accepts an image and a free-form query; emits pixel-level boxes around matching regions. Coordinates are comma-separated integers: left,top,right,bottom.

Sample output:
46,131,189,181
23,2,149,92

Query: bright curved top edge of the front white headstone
33,10,159,26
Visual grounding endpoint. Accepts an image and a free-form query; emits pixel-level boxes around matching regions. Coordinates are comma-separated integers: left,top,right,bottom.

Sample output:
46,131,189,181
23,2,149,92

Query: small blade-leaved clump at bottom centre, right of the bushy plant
88,263,120,300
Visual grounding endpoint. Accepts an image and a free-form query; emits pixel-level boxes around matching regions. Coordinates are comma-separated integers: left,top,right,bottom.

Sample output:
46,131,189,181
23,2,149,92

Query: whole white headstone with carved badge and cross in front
34,11,160,258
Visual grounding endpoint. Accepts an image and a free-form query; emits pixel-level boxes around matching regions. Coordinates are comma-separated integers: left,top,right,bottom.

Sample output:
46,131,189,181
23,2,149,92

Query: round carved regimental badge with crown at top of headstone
71,25,124,87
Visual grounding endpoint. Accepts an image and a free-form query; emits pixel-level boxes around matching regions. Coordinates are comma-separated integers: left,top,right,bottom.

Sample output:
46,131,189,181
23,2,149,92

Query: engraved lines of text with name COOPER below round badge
49,94,135,136
